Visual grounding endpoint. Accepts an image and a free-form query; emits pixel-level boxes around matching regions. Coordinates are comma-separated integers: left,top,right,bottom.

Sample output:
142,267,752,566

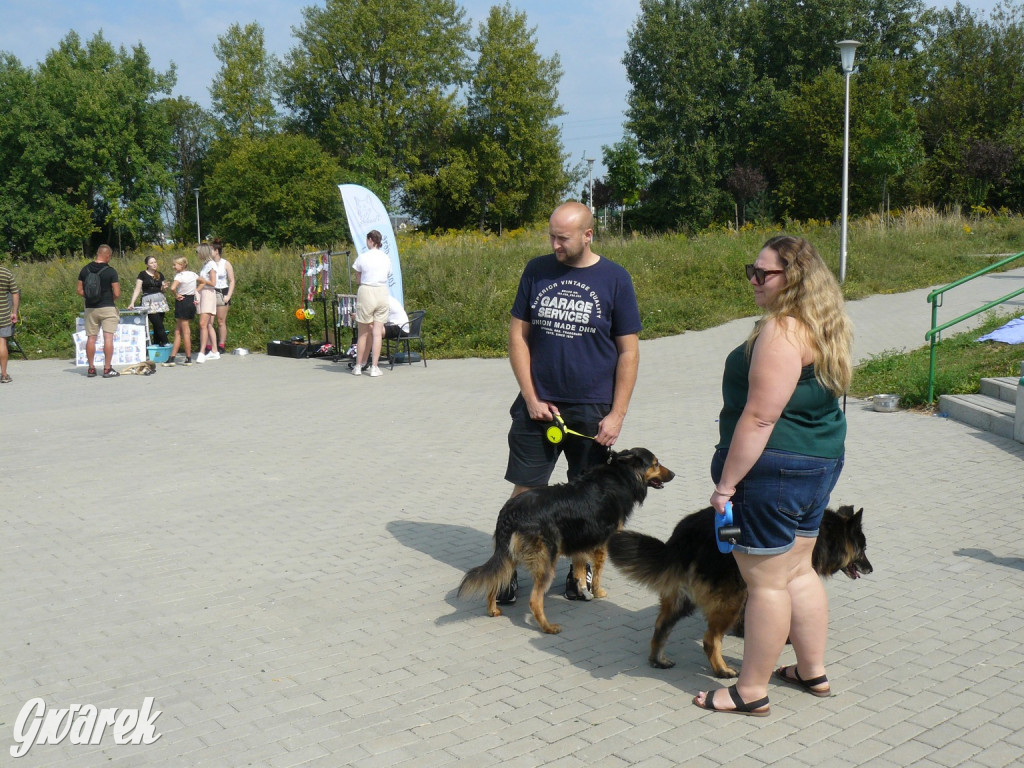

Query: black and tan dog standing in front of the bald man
459,447,676,635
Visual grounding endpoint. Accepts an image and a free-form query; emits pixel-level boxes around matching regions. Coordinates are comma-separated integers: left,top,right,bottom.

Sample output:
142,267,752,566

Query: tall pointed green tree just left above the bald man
402,3,570,231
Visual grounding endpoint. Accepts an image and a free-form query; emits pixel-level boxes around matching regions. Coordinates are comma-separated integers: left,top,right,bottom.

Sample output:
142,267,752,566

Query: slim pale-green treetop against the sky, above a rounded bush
210,22,278,136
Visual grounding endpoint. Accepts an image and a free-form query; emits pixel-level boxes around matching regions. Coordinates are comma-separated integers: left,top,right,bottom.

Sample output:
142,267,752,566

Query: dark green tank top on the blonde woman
718,344,846,459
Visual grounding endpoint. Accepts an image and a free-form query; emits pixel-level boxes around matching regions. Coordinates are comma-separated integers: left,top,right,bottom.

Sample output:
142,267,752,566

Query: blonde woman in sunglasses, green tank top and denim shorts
693,236,853,717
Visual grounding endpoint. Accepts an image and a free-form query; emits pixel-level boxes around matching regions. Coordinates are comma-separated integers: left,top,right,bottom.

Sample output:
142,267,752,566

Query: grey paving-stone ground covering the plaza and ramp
6,270,1024,768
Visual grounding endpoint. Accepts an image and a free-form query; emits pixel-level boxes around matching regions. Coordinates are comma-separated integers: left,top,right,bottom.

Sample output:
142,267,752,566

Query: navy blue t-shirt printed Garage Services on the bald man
512,253,642,403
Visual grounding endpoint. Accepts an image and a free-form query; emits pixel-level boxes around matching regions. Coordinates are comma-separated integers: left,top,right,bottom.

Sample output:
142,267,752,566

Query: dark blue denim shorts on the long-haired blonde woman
711,449,844,555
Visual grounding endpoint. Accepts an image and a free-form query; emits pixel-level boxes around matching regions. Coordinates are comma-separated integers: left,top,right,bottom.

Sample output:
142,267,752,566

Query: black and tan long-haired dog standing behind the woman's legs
608,506,872,677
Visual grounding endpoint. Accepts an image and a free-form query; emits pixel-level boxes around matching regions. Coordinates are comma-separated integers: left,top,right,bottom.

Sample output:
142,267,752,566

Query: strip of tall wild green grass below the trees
12,209,1024,391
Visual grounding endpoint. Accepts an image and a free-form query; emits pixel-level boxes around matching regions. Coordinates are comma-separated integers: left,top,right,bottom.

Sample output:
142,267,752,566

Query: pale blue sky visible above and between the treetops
0,0,995,185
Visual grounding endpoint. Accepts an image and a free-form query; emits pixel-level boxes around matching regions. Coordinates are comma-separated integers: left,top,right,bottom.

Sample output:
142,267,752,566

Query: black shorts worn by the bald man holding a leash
505,394,611,488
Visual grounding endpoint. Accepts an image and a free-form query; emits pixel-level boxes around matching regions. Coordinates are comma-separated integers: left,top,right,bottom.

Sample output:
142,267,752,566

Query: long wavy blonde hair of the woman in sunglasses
746,234,853,397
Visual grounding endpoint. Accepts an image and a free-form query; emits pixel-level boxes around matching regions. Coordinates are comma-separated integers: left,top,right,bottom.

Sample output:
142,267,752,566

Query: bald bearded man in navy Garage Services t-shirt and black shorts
499,202,641,604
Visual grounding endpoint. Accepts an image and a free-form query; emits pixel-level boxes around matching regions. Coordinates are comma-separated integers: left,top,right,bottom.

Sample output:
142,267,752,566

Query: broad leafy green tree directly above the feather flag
281,0,469,200
